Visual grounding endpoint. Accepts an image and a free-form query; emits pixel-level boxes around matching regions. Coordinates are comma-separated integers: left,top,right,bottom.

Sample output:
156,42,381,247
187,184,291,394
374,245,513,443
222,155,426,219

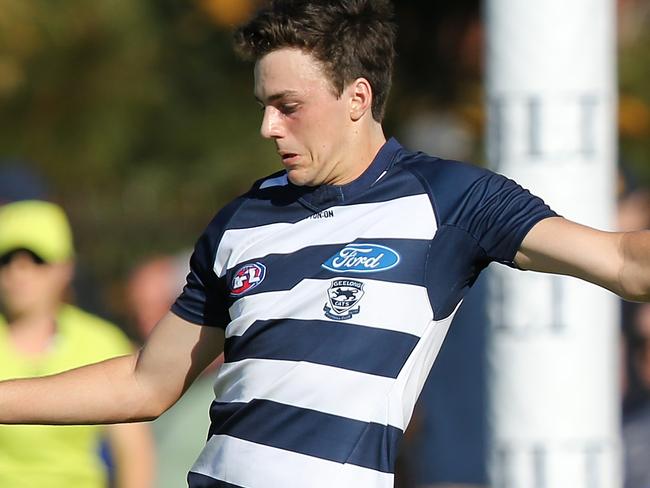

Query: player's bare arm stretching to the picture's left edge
0,312,224,424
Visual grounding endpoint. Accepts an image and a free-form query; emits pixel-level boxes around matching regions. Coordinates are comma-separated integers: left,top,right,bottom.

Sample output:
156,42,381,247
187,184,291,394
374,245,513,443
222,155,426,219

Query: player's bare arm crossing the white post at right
515,217,650,301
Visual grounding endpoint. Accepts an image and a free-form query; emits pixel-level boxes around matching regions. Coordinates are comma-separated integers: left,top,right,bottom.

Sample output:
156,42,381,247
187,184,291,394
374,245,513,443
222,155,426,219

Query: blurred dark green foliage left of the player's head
0,0,278,286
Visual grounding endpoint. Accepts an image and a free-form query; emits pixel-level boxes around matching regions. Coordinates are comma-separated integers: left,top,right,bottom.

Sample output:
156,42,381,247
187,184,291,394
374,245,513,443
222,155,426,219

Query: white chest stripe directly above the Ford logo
214,194,436,277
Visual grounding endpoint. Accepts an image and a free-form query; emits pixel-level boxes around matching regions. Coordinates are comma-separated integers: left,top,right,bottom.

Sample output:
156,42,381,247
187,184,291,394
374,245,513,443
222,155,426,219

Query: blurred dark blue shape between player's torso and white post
409,277,488,488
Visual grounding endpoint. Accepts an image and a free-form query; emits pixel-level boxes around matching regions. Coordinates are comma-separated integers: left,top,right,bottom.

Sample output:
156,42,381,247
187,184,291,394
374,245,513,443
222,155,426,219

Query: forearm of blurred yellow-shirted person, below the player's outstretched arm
106,422,155,488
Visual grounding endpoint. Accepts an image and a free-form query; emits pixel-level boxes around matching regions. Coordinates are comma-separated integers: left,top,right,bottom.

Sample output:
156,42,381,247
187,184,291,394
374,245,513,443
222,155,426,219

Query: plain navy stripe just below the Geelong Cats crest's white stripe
225,319,418,378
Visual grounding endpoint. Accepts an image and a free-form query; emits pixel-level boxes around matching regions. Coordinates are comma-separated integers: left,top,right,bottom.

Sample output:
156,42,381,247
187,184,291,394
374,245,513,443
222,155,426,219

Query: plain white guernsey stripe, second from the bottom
214,359,404,429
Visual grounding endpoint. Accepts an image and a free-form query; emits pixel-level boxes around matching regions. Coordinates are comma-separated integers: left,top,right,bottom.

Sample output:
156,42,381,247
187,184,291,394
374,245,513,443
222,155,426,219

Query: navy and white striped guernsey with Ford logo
172,139,555,488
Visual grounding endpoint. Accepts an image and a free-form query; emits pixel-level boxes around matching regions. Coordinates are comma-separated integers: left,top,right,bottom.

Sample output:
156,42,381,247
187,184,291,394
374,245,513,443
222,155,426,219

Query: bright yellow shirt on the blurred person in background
0,305,132,488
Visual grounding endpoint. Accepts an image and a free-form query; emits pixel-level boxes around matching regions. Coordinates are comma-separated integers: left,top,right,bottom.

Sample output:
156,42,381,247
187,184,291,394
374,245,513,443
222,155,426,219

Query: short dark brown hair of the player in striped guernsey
234,0,396,122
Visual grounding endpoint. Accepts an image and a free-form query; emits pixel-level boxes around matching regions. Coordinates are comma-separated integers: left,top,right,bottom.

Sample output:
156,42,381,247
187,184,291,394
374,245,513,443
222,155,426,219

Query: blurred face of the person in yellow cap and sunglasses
0,251,72,317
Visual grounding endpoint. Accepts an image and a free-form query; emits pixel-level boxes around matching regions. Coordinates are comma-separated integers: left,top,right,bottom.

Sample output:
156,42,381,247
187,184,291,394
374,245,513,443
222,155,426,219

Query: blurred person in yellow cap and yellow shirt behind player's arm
0,200,153,488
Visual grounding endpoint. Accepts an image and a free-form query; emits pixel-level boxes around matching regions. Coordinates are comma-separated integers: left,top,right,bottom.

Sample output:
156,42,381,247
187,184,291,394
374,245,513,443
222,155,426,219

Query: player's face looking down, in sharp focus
255,48,356,186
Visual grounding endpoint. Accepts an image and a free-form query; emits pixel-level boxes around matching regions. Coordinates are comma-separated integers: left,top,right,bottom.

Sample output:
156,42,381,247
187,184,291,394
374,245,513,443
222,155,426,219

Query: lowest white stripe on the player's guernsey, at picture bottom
191,435,393,488
